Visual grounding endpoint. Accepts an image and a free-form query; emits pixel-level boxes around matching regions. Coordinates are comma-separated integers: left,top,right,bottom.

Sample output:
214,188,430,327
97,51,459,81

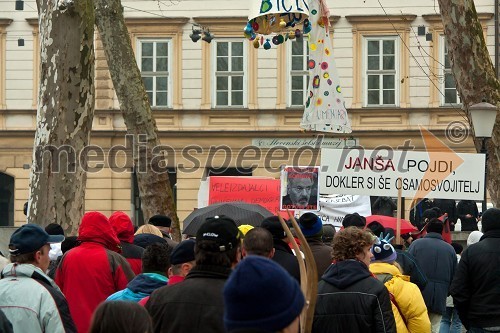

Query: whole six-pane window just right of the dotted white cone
365,36,398,106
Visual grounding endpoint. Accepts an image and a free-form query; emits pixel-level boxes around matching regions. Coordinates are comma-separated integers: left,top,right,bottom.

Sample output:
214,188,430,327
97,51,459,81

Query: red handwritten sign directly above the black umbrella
208,176,280,213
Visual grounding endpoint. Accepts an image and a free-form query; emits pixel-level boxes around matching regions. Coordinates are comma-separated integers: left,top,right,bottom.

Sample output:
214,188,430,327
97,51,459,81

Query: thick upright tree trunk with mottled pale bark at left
28,0,94,235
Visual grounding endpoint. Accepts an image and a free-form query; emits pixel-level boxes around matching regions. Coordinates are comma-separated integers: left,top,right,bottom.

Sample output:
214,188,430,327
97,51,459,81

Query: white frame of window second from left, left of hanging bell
211,38,248,109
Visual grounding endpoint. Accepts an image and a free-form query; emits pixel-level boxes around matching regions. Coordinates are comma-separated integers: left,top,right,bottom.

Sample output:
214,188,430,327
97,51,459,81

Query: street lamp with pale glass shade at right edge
469,101,497,213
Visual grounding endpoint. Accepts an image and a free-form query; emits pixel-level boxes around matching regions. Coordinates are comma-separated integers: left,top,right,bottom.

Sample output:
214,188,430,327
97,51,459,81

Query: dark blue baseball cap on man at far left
9,223,64,255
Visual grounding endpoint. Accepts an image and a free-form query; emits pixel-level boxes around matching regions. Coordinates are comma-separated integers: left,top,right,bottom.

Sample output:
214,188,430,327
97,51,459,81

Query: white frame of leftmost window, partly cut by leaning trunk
136,38,173,109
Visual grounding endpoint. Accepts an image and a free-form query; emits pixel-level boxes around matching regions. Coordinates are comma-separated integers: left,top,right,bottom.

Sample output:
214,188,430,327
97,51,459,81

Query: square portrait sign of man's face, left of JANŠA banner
280,166,319,210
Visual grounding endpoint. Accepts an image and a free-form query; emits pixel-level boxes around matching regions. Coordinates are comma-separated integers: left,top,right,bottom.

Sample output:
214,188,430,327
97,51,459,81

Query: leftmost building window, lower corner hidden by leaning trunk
138,39,172,107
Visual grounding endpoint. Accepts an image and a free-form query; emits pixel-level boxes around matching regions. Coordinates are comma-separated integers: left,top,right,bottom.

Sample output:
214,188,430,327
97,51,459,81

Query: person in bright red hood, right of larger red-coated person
109,212,144,275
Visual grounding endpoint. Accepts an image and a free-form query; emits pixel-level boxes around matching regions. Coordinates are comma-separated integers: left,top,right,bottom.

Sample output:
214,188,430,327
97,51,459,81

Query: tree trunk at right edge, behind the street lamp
438,0,500,207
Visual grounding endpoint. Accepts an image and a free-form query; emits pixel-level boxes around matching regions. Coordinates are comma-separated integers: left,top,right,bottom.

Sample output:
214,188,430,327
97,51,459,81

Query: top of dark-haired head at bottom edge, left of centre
89,301,153,333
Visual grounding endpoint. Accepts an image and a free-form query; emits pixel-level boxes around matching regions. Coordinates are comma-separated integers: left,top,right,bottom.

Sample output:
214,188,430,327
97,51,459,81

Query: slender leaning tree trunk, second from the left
94,0,180,240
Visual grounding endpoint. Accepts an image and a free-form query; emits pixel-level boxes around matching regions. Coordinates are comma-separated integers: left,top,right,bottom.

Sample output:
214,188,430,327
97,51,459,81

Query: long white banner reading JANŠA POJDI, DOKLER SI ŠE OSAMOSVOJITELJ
319,148,485,200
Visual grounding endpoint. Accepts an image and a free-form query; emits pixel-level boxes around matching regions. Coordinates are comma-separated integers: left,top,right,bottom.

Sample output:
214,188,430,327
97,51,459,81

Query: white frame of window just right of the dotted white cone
362,35,401,107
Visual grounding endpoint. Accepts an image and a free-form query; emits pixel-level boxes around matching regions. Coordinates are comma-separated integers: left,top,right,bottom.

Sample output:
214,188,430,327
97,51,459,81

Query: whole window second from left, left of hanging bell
214,40,246,107
